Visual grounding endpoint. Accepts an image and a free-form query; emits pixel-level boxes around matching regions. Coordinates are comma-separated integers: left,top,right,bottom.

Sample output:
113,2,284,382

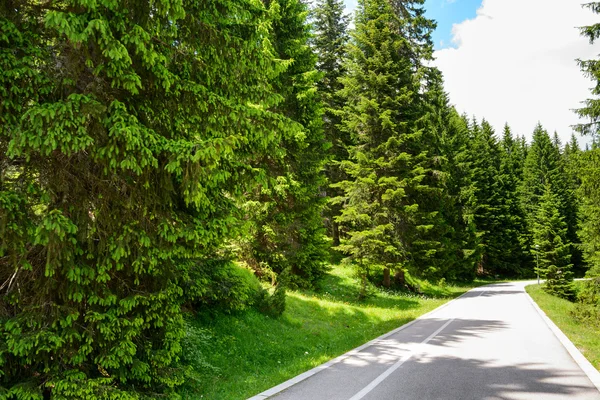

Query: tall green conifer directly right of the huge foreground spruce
247,0,327,286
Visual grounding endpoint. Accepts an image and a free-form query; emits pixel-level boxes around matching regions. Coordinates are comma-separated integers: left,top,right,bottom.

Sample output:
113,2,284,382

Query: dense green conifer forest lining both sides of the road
0,0,600,399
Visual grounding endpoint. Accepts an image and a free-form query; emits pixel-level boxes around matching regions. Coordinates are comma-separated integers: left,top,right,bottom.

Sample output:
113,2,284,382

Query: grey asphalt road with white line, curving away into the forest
258,282,600,400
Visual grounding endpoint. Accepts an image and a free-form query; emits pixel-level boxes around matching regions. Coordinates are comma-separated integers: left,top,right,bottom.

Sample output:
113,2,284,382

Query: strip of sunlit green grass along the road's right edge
525,282,600,370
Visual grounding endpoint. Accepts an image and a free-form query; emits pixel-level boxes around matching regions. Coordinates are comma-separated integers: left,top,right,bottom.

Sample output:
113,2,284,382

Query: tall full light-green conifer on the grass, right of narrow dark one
338,0,435,294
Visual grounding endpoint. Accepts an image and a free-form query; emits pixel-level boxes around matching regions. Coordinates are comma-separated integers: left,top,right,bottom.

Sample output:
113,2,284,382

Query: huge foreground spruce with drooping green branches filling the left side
0,0,290,399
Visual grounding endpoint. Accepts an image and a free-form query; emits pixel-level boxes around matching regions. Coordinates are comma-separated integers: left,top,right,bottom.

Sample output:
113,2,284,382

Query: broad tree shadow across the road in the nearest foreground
376,357,600,400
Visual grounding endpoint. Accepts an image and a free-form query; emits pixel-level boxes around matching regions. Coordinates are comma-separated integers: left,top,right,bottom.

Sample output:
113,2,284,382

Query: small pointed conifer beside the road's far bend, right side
533,184,575,299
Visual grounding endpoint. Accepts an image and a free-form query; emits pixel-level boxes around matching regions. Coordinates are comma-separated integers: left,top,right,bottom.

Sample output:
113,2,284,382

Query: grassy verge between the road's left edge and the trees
182,266,489,400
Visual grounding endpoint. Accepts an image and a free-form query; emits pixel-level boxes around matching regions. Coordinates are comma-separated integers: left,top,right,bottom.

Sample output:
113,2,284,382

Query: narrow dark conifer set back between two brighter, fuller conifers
313,0,351,246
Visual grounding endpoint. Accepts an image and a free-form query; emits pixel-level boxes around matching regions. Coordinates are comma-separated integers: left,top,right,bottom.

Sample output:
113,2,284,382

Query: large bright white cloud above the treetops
435,0,600,143
